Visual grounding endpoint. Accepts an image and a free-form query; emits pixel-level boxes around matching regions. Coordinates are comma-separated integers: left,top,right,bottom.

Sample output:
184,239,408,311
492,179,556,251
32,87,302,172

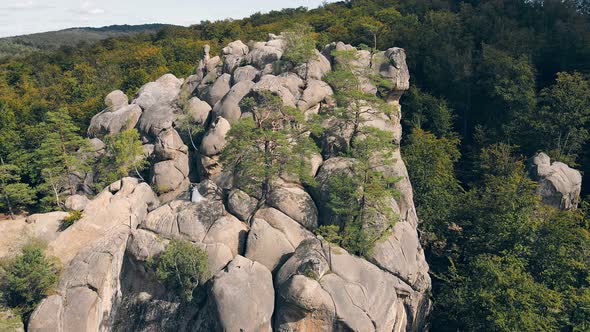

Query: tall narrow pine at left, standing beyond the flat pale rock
37,108,90,207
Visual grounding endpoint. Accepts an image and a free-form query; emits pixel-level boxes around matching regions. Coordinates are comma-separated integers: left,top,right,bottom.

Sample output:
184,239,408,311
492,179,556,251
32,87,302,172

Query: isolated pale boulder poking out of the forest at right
532,152,582,210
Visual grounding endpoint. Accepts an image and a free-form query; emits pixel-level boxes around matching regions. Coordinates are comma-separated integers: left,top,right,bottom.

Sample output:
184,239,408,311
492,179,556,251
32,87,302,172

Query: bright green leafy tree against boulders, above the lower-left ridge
99,128,148,186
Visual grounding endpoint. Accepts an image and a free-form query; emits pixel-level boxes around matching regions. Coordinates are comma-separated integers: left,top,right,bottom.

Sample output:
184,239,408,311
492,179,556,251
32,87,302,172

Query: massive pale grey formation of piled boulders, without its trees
28,35,431,332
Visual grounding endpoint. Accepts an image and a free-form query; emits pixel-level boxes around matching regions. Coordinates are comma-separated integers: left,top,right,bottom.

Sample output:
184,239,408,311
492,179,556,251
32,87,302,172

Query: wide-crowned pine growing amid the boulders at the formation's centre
220,92,317,210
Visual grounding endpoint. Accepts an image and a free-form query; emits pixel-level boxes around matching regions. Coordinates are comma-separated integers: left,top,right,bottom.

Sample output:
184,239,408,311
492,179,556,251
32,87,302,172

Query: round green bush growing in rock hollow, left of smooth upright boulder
154,240,209,302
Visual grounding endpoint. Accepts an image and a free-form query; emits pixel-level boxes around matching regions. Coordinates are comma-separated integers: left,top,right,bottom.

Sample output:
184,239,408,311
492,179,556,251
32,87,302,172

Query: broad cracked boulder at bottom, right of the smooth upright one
275,239,409,331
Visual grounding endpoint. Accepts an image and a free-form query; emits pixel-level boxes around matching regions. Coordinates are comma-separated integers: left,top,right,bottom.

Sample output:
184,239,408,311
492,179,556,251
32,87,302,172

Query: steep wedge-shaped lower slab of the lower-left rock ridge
28,229,130,332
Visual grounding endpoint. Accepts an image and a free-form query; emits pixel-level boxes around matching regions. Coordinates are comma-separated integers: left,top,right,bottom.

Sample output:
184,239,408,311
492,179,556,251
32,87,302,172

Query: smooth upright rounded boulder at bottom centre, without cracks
210,256,275,332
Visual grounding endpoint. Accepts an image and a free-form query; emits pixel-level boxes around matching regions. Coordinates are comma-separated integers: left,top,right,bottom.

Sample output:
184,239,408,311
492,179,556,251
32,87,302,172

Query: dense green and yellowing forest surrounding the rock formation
0,0,590,331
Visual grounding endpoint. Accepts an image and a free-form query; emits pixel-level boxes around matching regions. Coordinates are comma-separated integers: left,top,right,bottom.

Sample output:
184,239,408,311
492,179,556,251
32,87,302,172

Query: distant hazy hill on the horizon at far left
0,24,175,59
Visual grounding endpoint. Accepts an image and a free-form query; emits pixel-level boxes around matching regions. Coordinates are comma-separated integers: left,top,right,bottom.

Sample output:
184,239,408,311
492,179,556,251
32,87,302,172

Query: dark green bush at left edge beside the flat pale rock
0,243,60,317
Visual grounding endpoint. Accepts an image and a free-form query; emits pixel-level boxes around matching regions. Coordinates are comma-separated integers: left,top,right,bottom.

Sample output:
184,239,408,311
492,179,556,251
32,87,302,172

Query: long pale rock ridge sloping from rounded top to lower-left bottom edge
28,178,159,332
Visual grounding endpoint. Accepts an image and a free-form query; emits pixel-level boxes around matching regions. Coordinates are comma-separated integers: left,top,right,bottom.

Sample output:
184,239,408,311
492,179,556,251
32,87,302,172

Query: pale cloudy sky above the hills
0,0,333,37
